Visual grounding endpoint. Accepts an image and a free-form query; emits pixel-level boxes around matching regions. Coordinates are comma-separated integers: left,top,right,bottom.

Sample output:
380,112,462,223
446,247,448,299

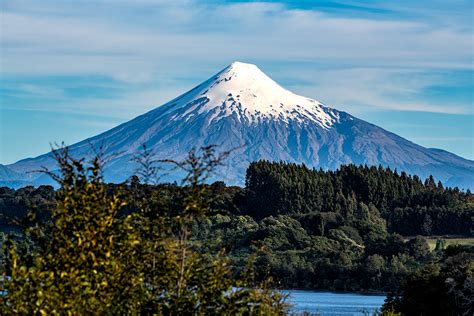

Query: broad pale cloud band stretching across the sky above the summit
2,2,472,72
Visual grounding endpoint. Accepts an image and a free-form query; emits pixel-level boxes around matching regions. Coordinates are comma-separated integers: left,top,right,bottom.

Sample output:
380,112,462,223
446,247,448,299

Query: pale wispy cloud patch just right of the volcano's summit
289,67,473,114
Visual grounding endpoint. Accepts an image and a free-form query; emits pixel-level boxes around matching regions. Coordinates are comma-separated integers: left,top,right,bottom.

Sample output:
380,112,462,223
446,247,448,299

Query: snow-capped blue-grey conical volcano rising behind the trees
0,62,474,188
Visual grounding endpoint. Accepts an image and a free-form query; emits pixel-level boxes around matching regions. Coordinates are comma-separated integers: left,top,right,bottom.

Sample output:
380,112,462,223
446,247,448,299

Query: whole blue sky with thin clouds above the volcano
0,0,474,164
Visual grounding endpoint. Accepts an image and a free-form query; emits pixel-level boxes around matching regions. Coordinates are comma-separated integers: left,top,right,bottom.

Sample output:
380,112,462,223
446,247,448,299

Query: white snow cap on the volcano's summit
167,61,338,128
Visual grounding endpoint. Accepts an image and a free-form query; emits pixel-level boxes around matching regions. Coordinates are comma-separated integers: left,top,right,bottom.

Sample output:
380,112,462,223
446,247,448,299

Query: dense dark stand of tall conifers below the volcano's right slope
241,161,474,236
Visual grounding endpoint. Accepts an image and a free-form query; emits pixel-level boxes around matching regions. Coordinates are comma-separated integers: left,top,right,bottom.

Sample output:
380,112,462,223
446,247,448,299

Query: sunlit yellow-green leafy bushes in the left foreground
0,148,286,315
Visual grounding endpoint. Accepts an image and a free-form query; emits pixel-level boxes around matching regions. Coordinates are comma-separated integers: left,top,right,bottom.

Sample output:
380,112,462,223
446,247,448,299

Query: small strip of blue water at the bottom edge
282,290,385,316
